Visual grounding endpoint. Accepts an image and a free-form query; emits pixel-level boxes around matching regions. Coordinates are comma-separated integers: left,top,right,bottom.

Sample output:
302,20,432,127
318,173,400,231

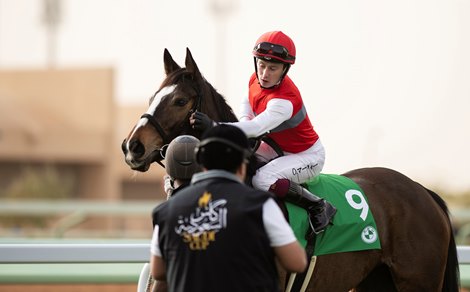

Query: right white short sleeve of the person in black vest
263,198,297,246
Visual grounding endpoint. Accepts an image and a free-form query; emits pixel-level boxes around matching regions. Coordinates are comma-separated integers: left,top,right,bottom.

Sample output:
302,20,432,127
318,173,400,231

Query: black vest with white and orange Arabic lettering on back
152,178,279,292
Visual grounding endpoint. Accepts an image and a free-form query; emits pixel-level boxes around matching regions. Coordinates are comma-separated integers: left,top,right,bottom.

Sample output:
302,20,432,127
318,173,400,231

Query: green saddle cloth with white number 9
286,174,381,255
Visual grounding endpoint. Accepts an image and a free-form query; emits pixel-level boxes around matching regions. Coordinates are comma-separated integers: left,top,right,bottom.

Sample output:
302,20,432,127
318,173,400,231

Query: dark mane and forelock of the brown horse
160,68,237,122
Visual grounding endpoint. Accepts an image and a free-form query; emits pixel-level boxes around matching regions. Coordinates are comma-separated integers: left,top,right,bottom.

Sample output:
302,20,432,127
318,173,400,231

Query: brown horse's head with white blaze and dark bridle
122,49,239,172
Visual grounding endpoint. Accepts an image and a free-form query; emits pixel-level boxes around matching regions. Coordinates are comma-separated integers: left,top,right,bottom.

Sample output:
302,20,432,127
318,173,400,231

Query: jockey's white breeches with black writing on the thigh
252,140,325,191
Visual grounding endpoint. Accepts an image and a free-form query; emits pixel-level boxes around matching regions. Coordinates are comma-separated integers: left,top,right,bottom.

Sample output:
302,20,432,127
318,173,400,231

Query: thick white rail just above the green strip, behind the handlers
0,243,470,264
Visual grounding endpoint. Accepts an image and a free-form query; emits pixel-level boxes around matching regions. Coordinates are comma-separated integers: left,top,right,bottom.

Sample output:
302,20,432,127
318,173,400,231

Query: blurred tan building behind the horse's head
0,68,164,201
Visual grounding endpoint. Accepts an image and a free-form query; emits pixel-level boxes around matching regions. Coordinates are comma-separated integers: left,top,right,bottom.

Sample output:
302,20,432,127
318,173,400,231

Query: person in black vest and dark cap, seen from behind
150,124,307,292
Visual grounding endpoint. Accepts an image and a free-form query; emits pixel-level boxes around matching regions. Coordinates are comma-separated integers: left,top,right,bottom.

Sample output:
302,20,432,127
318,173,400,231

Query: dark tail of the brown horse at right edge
426,189,460,292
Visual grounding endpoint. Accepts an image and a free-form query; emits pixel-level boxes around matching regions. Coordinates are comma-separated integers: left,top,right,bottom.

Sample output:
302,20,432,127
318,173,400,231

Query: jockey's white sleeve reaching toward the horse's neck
230,98,294,138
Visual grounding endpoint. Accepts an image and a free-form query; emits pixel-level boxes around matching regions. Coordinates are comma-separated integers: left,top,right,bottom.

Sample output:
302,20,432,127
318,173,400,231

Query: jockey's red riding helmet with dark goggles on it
253,31,295,65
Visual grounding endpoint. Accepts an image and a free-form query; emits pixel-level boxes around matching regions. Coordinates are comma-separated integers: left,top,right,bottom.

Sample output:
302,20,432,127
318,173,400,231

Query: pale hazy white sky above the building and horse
0,0,470,191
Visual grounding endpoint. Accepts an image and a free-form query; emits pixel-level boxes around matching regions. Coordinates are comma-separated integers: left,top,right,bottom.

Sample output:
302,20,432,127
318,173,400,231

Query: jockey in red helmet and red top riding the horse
190,31,336,233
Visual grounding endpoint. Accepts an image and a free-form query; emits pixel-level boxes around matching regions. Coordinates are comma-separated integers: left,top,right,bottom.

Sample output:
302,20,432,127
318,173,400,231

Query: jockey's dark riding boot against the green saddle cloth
270,179,336,234
